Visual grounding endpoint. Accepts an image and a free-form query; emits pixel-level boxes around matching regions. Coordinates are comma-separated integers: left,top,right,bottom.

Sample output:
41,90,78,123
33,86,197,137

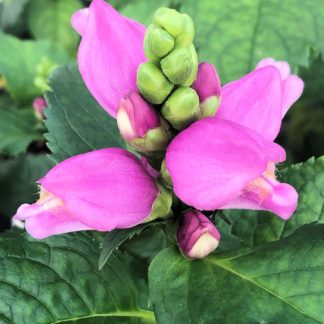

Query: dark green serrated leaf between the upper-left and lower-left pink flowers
45,64,124,162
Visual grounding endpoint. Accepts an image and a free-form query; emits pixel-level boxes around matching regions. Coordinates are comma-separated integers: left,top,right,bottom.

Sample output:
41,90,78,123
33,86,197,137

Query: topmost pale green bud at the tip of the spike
153,8,195,47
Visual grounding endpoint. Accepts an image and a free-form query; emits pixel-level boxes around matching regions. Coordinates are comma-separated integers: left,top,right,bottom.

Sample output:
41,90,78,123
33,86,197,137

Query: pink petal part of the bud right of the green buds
192,62,221,102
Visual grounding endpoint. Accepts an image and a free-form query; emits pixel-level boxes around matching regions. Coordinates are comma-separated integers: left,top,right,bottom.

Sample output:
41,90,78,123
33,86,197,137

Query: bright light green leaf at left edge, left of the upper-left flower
0,31,69,103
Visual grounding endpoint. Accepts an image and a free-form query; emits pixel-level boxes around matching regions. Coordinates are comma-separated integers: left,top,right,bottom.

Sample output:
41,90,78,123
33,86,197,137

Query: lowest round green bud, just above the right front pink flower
162,87,200,130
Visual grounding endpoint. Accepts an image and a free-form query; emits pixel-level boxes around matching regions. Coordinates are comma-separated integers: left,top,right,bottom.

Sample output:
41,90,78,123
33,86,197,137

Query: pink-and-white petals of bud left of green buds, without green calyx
117,92,160,141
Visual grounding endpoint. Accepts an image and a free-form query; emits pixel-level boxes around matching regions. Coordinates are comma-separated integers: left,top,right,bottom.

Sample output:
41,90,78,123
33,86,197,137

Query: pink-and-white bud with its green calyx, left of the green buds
116,92,169,152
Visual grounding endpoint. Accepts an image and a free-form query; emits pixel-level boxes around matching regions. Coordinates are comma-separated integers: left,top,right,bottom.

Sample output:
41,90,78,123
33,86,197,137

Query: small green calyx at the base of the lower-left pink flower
145,183,172,222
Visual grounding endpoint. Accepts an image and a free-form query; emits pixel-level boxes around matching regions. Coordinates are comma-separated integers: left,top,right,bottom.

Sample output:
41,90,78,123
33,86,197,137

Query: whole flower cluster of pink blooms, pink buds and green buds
14,0,303,259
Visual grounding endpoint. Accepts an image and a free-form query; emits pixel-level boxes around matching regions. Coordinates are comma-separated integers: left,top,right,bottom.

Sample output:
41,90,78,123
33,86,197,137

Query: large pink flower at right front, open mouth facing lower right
166,118,297,219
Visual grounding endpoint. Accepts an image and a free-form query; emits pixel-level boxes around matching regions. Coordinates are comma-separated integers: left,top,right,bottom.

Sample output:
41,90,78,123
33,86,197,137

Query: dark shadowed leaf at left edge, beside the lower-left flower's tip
0,154,53,216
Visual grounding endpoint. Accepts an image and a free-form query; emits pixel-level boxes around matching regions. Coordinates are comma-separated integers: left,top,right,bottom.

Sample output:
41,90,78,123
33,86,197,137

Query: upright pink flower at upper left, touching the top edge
71,0,146,117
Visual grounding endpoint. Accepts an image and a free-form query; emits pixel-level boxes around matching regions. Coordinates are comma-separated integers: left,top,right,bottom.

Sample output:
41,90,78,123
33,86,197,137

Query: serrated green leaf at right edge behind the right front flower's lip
224,157,324,246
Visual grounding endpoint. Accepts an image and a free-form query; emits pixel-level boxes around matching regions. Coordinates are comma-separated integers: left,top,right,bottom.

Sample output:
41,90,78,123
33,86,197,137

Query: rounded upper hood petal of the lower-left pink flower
39,149,159,231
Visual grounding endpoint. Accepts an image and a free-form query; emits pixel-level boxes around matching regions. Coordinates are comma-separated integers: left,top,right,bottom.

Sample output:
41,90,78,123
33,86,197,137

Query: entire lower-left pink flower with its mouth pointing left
14,149,159,239
